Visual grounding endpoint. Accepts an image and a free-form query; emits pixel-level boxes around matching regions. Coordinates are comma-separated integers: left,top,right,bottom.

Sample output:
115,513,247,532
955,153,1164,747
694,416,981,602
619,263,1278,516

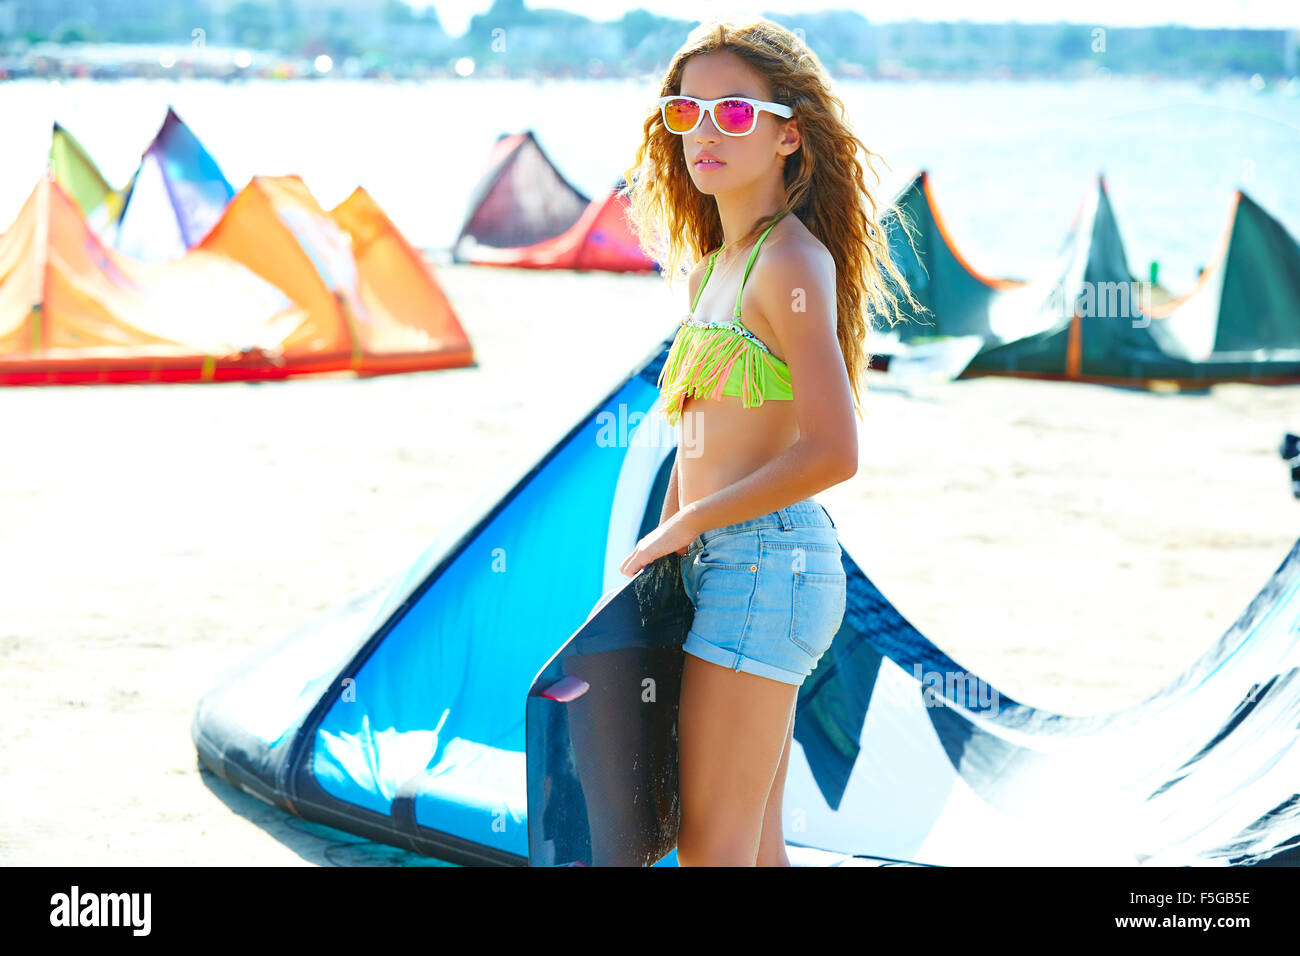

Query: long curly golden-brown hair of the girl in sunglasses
620,17,926,419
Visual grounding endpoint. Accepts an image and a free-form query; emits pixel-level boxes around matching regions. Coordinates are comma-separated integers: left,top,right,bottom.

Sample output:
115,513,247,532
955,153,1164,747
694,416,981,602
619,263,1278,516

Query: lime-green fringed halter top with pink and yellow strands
658,213,794,425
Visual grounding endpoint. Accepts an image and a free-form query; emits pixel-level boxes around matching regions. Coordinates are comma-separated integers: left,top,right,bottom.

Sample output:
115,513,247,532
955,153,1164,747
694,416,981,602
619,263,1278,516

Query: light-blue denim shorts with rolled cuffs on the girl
681,498,848,685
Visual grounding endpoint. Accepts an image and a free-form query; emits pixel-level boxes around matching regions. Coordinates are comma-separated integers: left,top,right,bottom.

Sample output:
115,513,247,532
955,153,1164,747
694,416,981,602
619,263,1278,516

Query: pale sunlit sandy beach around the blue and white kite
0,267,1300,865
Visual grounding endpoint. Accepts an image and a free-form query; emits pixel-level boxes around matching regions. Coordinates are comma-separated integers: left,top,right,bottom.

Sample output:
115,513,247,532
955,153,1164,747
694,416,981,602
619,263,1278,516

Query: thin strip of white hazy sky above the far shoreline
407,0,1300,36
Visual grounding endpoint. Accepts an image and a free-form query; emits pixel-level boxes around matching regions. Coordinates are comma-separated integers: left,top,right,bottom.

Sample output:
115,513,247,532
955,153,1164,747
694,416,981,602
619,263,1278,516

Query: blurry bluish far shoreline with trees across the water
0,13,1300,86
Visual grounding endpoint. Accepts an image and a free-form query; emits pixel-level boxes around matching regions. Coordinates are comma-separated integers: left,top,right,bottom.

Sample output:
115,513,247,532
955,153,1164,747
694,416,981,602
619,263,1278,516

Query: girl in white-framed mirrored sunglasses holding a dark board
621,18,919,866
